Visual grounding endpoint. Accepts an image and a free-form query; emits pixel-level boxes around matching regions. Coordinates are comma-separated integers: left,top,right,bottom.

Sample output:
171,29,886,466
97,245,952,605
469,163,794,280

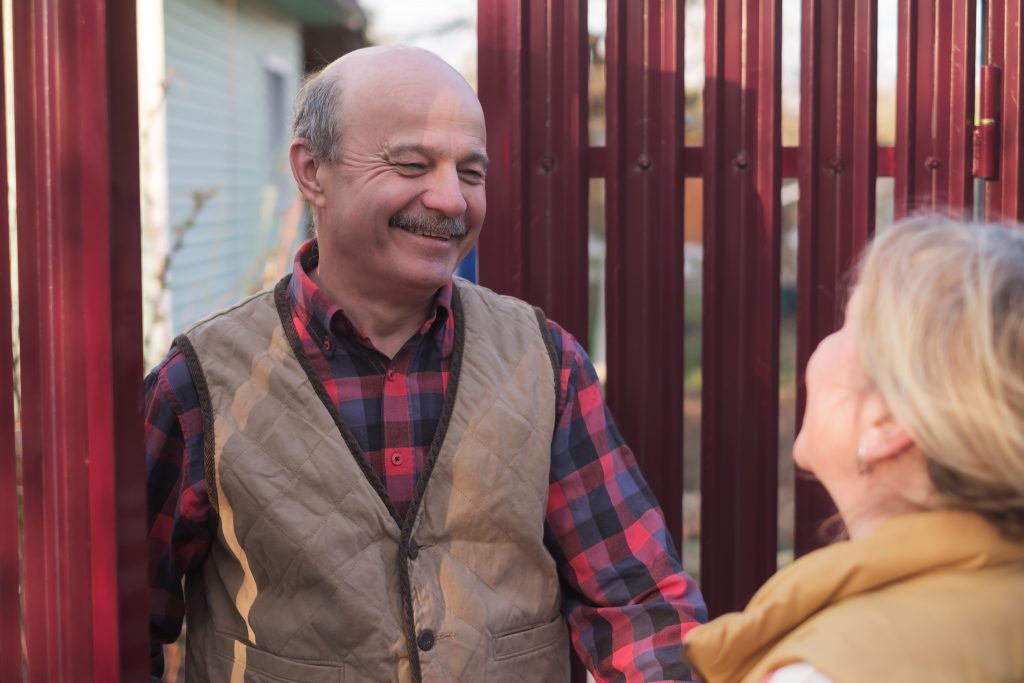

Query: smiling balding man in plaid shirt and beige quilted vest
146,47,706,682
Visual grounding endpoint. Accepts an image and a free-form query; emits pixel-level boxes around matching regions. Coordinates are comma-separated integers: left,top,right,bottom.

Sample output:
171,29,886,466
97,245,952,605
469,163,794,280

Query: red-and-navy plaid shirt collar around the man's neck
287,238,453,344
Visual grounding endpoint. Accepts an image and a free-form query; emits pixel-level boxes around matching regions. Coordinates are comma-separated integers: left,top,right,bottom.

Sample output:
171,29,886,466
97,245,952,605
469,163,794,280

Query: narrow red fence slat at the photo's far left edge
0,3,22,681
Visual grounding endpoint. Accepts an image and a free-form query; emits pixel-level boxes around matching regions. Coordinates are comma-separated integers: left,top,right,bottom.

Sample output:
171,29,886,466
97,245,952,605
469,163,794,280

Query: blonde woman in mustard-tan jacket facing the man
684,218,1024,683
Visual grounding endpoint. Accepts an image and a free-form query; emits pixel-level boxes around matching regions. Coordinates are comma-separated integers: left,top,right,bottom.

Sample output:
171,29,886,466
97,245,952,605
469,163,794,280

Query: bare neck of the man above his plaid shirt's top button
309,268,436,358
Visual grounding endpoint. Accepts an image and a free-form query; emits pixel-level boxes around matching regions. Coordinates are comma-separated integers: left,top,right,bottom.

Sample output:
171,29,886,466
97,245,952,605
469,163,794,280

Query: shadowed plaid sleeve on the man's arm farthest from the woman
144,349,212,678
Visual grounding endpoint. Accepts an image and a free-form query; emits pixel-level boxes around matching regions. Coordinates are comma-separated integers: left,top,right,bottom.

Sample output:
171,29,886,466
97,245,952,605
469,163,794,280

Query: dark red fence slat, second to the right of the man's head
605,0,684,541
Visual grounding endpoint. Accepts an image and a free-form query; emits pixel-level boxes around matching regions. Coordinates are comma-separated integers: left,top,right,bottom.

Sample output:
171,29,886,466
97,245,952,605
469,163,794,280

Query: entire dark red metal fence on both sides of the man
0,0,1024,681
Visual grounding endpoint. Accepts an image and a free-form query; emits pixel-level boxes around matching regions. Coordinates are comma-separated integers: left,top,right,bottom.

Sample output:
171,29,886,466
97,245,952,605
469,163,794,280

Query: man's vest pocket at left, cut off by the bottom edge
210,633,345,683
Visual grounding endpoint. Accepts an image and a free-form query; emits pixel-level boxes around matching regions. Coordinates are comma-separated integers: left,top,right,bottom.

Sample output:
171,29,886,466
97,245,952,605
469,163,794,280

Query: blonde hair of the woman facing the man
855,216,1024,538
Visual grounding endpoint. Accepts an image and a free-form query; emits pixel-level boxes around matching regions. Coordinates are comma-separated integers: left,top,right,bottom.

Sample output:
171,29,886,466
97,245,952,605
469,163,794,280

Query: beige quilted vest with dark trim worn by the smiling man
177,281,569,683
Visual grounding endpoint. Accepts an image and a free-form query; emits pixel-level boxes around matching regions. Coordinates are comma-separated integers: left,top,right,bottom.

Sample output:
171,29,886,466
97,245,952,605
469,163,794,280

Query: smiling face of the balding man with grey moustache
316,70,486,297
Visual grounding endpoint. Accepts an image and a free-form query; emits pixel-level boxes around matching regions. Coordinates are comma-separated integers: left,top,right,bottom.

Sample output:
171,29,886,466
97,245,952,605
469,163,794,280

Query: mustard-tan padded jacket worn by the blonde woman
685,511,1024,683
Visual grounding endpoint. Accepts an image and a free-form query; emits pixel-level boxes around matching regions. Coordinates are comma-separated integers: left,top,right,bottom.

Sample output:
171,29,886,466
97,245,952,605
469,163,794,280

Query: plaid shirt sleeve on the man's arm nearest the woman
545,322,708,683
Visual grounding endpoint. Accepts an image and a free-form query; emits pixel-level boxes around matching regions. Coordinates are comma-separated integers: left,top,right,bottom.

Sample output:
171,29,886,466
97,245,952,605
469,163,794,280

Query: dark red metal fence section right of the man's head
478,0,1024,651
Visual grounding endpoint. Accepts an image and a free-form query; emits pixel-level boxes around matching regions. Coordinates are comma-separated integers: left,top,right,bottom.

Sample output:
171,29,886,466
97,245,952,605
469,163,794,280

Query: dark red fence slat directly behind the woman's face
795,0,878,555
